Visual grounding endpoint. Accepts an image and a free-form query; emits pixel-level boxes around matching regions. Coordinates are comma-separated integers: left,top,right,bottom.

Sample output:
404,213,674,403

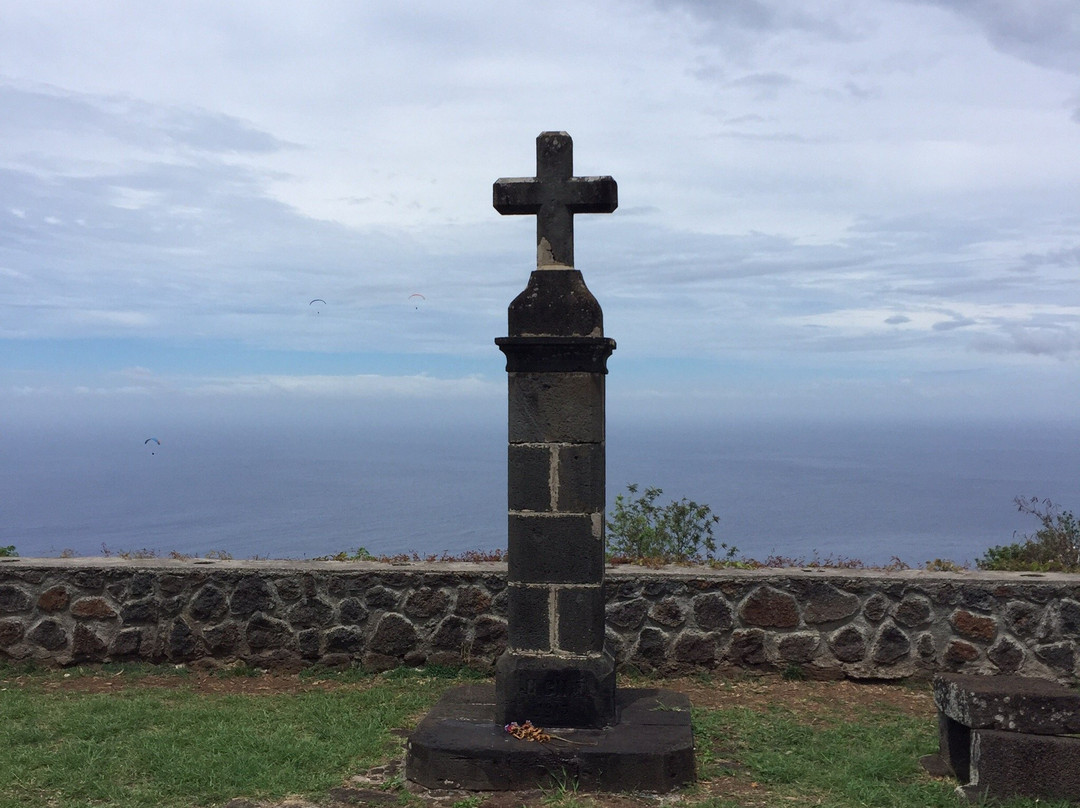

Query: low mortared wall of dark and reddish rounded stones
0,558,1080,683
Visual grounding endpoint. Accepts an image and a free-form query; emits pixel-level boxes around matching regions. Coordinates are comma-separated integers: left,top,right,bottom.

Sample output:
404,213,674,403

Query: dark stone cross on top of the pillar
495,132,619,269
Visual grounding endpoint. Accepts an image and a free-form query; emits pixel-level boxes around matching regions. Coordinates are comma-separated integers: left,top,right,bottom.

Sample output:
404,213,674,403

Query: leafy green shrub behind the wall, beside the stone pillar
607,483,738,563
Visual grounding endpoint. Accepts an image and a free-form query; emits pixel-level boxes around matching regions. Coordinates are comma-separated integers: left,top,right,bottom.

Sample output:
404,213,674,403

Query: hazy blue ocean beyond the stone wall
0,419,1080,566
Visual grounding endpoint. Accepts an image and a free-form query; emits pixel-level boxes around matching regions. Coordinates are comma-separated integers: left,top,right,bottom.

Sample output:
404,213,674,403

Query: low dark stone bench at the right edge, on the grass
921,674,1080,802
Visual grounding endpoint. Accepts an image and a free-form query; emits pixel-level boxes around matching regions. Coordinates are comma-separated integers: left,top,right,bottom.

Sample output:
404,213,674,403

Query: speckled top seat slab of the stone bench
934,674,1080,735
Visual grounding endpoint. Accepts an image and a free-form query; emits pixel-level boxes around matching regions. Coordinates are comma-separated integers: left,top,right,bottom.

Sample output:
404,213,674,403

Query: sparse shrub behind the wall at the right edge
975,497,1080,573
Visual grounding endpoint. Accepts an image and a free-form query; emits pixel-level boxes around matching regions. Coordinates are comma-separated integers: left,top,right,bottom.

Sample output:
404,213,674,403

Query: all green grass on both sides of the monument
0,665,1064,808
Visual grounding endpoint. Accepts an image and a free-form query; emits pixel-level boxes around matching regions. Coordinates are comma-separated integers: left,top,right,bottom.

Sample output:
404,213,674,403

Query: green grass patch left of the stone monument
0,674,448,808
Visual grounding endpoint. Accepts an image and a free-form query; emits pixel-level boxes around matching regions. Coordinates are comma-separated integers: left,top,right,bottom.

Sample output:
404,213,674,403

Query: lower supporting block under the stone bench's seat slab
960,729,1080,803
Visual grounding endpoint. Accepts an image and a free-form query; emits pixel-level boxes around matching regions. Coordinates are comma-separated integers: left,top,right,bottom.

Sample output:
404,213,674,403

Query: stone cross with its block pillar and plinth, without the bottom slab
494,132,618,727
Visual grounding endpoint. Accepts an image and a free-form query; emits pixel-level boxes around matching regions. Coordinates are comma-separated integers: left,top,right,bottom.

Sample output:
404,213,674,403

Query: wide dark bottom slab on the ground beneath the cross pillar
405,685,694,793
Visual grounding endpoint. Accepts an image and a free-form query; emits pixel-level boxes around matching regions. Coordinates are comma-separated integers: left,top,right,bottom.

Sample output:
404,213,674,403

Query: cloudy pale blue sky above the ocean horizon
0,0,1080,426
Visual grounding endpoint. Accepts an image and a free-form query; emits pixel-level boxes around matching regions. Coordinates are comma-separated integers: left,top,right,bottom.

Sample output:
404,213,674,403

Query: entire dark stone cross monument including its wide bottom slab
406,132,694,792
